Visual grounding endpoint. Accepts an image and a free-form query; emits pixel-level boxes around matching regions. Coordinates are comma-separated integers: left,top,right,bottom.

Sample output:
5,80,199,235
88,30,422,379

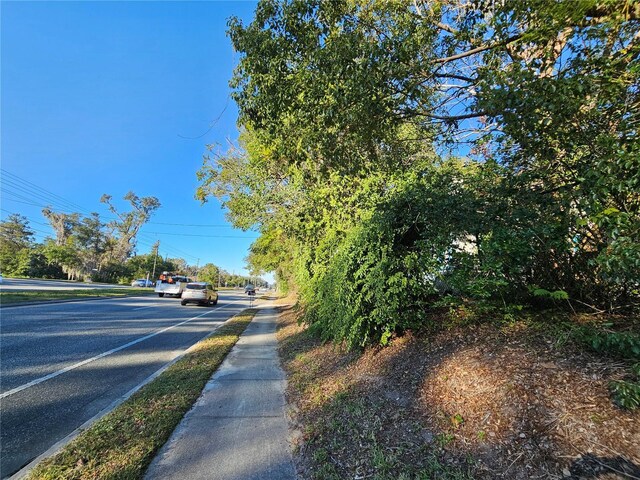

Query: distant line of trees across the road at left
0,192,266,286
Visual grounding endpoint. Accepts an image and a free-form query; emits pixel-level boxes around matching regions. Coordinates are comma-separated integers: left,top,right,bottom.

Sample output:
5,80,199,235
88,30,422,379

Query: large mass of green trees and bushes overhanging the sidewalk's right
198,0,640,349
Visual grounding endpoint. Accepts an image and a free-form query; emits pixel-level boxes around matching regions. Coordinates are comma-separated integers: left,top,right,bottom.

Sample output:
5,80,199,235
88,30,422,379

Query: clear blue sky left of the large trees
1,1,264,273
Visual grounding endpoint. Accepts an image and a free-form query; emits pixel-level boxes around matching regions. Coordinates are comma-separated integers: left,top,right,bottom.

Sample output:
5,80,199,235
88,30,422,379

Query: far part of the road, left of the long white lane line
0,295,244,393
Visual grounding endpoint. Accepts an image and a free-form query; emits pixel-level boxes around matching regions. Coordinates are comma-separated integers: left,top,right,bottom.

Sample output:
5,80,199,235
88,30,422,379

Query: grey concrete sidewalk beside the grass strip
145,308,297,480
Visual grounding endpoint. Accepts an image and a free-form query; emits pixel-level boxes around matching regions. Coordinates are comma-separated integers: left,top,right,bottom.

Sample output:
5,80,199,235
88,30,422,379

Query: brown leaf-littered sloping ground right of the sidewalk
278,309,640,479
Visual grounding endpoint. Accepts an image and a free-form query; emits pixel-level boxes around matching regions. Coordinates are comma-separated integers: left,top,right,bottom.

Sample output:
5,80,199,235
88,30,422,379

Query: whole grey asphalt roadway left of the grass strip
0,291,255,478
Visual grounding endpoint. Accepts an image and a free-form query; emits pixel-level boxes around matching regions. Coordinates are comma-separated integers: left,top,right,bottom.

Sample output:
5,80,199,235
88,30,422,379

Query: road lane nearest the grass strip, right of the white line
0,303,250,477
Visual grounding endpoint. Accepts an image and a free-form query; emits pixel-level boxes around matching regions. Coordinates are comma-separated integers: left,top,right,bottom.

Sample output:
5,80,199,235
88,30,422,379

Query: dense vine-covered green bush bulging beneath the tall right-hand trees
296,160,592,347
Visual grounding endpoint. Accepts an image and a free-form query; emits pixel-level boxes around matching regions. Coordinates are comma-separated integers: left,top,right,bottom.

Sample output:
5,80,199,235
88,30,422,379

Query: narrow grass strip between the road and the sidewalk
28,309,257,479
